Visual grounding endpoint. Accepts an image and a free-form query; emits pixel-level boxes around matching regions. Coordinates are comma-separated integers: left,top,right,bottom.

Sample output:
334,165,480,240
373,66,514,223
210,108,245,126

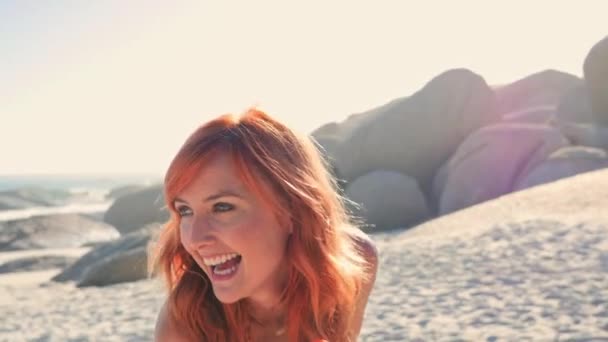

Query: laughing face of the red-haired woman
174,153,289,303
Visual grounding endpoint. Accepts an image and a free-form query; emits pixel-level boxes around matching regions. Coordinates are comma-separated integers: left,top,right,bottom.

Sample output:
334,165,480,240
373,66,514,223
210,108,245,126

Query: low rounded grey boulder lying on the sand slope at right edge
514,146,608,191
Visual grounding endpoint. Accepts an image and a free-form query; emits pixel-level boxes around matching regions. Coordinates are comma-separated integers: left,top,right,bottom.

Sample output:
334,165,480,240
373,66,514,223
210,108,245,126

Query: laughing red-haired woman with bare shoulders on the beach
152,109,377,342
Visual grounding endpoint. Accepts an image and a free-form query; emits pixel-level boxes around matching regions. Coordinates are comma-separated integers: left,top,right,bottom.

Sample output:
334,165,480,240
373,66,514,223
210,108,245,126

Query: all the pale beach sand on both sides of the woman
0,172,608,341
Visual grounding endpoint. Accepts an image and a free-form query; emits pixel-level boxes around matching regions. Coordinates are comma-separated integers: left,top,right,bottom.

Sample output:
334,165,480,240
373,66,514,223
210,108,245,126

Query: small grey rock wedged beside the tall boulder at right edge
555,84,594,124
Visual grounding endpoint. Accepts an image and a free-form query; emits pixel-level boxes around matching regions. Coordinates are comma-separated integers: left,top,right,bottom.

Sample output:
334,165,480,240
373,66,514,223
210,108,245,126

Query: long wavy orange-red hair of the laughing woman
150,109,369,342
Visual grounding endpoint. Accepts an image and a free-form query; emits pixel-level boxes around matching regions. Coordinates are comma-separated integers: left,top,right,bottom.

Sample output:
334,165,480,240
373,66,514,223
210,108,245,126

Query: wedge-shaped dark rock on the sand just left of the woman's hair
52,223,161,286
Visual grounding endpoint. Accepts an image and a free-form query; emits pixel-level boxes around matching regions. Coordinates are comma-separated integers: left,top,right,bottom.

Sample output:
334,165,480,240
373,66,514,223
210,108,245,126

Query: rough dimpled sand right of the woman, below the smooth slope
362,221,608,341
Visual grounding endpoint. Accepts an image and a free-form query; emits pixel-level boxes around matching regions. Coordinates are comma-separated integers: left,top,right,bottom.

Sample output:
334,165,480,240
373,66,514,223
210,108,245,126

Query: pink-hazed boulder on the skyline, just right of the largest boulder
495,70,583,114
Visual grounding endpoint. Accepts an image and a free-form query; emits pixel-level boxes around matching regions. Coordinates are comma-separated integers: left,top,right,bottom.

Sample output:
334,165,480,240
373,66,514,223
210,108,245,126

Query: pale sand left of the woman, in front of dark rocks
0,264,163,342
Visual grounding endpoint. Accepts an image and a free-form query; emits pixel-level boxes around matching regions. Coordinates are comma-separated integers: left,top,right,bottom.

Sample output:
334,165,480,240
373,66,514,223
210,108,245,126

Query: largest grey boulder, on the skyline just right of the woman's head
320,69,499,189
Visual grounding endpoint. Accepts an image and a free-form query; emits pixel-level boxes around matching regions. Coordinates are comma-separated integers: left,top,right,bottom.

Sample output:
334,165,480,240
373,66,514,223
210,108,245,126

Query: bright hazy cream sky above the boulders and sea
0,0,608,175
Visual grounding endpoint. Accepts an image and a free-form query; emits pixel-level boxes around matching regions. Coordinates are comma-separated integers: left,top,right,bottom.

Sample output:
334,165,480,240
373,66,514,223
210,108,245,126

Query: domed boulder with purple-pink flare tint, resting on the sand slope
433,123,567,215
